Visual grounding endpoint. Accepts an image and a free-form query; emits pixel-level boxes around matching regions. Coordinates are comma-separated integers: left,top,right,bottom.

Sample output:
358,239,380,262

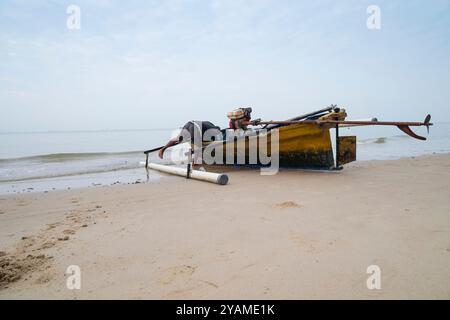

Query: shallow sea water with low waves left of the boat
0,130,179,194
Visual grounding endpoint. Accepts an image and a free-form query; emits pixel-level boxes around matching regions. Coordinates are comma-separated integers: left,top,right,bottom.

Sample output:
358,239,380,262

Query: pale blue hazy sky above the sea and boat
0,0,450,132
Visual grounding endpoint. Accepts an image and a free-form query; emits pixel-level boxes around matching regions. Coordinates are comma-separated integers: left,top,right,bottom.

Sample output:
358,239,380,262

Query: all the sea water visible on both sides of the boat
0,123,450,194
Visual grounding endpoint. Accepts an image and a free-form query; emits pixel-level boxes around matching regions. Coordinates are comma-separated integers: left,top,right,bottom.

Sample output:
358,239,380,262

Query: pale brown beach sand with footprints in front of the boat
0,155,450,299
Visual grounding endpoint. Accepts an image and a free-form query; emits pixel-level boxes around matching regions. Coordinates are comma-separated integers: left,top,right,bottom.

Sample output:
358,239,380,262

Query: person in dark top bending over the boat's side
158,121,222,159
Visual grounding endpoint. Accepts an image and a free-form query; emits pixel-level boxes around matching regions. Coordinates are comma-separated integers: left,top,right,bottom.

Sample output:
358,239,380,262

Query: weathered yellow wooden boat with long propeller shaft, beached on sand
144,105,433,181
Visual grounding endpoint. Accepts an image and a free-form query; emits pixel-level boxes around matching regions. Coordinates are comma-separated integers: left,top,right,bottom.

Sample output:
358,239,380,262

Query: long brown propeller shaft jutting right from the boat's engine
259,115,433,140
